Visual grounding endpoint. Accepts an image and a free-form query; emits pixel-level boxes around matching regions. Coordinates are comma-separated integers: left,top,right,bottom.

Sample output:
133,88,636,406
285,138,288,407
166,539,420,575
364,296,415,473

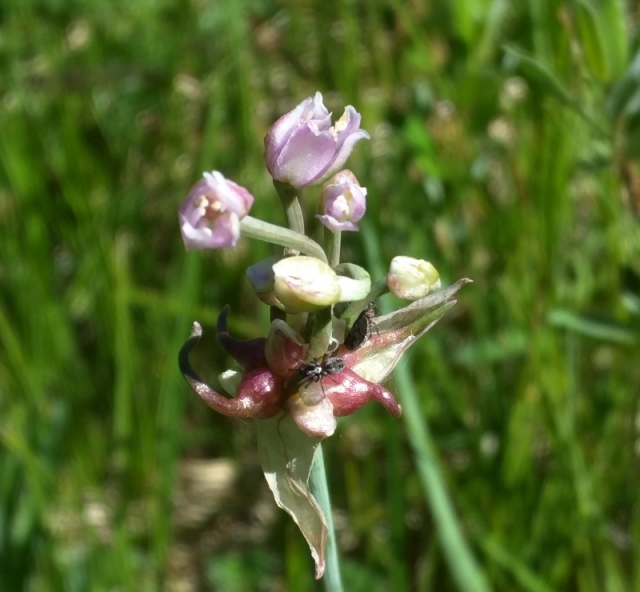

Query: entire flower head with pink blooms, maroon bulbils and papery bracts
179,93,468,577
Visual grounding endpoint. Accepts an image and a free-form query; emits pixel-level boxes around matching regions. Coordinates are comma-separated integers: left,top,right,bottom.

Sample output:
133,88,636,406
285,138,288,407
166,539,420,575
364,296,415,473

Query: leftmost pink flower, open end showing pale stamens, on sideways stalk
179,171,253,250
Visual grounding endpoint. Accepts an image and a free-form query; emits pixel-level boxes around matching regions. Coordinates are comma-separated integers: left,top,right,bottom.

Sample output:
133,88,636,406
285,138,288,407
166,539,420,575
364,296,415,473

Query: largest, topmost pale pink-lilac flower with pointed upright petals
264,92,369,188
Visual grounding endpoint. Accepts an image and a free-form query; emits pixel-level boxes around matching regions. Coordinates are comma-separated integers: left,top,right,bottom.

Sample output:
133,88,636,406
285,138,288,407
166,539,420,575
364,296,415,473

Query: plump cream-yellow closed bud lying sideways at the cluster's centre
273,256,341,314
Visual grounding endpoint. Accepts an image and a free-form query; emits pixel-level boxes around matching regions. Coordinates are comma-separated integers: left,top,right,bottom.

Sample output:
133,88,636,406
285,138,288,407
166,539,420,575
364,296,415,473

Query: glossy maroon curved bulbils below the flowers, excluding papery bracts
178,306,401,438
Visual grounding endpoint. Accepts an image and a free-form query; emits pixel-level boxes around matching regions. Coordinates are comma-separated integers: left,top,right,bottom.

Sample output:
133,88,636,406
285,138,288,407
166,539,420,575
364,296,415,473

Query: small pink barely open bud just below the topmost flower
316,170,367,232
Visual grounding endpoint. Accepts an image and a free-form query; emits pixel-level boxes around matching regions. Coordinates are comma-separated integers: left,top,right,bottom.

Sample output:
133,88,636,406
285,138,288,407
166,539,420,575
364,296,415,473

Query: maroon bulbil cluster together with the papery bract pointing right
179,280,468,439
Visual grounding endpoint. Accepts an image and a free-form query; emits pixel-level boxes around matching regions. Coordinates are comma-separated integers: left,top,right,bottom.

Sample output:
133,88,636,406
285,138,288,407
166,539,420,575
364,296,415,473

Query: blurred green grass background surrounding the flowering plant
0,0,640,592
